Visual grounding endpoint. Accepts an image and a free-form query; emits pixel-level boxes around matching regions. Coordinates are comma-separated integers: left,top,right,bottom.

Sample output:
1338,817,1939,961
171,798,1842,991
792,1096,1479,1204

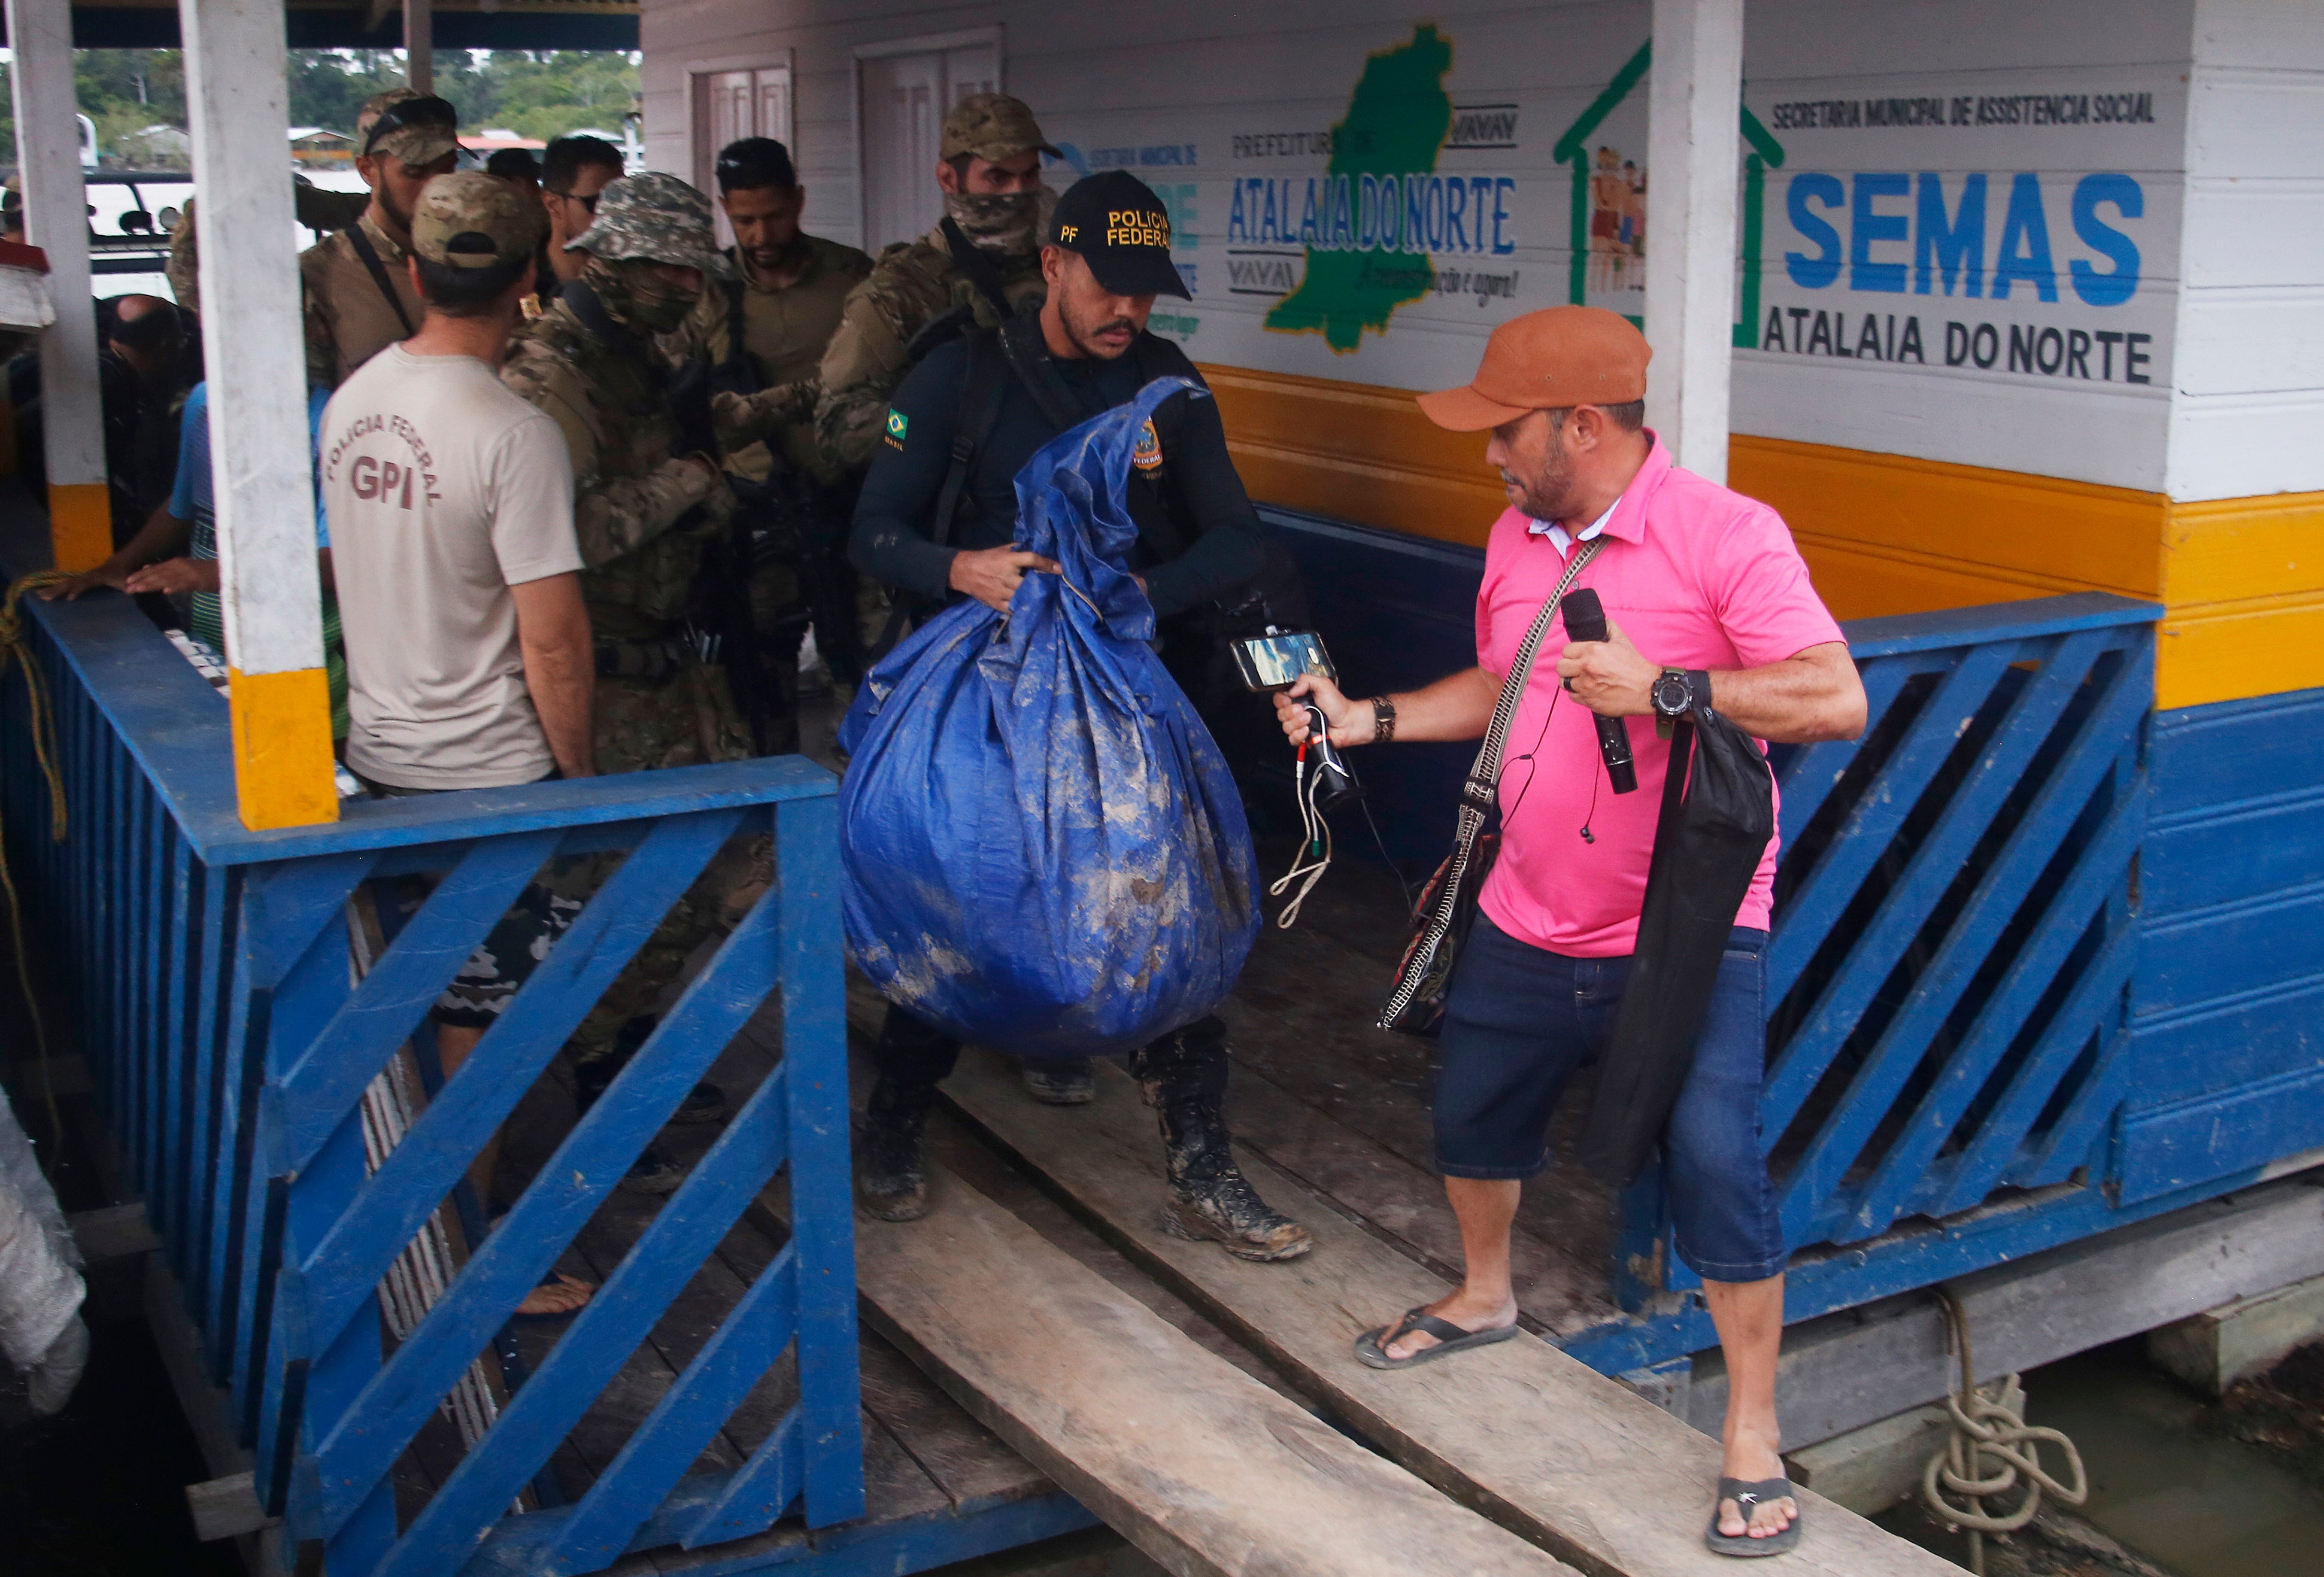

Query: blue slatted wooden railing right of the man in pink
1615,594,2159,1365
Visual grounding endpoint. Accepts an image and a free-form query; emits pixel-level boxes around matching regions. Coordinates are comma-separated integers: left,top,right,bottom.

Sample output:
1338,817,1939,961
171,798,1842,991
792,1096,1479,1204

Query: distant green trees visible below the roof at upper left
0,48,639,165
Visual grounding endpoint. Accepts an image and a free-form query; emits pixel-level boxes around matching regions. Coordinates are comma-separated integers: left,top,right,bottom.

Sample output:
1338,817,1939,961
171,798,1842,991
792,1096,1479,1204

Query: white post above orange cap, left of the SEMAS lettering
1645,0,1743,483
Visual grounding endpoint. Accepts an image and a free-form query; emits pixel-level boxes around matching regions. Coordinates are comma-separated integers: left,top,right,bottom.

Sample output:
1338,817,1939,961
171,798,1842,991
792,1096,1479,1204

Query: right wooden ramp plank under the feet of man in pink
934,1050,1957,1577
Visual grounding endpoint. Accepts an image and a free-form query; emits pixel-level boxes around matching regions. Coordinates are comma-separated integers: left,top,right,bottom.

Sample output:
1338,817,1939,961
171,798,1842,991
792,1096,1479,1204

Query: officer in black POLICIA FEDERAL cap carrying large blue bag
848,169,1310,1261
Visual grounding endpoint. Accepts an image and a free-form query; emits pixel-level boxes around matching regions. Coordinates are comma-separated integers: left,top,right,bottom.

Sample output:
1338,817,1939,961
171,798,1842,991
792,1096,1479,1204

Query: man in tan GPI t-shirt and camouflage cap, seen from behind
321,172,597,1314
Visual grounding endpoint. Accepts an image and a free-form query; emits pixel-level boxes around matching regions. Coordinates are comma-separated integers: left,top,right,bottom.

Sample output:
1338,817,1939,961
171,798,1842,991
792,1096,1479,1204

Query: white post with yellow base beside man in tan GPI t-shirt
179,0,339,827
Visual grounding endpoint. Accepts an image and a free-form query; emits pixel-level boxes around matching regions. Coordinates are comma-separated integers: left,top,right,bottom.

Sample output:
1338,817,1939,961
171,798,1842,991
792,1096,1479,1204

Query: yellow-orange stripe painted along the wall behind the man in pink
1202,364,2324,706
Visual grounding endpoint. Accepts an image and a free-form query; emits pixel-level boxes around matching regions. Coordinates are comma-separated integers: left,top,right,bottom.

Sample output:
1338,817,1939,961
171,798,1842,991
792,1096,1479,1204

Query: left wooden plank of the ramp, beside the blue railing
836,1147,1571,1577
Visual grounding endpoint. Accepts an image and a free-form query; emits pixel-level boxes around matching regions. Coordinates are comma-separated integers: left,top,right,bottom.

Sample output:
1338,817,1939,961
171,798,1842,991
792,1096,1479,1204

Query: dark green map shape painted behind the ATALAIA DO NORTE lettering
1267,23,1452,353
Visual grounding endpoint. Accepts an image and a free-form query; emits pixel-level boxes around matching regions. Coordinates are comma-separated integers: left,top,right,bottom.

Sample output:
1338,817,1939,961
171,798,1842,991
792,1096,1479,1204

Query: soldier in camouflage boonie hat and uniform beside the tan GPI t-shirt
500,174,772,1192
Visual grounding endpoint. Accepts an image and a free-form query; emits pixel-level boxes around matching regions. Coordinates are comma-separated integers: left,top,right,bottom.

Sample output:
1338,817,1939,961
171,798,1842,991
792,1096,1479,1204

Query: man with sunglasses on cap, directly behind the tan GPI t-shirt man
298,88,460,388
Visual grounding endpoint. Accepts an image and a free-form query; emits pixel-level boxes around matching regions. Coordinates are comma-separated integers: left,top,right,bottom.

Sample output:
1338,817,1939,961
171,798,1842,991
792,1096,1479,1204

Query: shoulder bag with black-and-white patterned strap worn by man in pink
1381,536,1606,1036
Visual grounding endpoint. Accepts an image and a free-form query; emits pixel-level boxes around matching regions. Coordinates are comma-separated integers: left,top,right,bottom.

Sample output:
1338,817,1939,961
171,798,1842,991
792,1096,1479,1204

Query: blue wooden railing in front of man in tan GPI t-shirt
0,585,864,1577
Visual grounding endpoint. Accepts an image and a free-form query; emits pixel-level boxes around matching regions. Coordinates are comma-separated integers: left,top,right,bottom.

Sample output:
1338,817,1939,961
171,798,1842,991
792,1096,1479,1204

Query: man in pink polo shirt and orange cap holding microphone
1276,306,1864,1554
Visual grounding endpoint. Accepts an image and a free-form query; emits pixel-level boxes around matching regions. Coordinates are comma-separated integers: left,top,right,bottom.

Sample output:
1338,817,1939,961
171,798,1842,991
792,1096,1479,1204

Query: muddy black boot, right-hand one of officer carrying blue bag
1130,1020,1315,1263
